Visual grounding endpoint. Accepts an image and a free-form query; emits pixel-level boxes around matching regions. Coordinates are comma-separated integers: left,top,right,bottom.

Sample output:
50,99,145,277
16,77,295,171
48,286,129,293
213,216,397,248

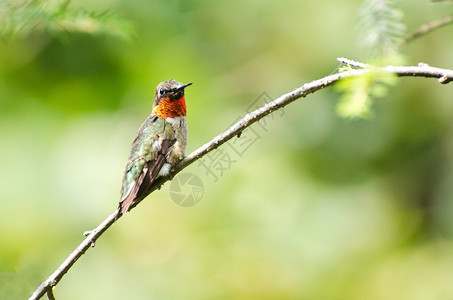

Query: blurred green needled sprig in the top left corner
0,0,132,38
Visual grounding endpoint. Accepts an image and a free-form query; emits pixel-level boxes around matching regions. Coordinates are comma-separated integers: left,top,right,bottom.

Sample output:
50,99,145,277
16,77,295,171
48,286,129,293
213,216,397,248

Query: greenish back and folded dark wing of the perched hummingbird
119,117,176,214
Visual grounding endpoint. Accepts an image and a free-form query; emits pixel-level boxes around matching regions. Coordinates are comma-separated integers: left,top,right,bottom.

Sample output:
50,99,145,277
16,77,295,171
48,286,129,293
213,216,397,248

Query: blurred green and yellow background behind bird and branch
0,0,453,300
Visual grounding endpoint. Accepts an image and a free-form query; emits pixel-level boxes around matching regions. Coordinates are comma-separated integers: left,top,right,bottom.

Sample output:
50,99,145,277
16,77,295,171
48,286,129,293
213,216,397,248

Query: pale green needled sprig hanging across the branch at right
337,0,406,118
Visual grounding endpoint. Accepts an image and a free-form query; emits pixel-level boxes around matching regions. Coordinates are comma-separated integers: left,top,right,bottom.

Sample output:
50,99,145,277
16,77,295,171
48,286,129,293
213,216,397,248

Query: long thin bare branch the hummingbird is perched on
29,58,453,300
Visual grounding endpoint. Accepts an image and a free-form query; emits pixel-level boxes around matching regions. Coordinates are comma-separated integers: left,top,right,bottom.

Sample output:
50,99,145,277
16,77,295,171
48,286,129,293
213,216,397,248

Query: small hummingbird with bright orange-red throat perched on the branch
119,79,192,214
